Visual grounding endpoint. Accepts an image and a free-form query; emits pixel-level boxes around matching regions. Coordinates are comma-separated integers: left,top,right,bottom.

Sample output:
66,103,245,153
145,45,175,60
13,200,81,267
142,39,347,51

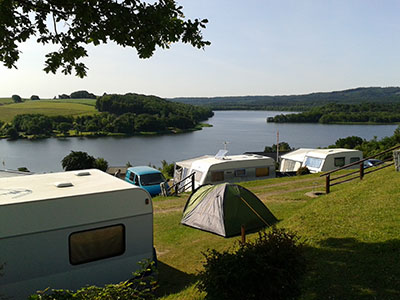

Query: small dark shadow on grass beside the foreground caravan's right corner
156,261,196,297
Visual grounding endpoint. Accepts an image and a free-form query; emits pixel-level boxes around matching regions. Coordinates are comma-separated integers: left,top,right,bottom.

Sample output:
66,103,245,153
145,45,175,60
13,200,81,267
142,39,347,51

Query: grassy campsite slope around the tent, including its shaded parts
154,167,400,299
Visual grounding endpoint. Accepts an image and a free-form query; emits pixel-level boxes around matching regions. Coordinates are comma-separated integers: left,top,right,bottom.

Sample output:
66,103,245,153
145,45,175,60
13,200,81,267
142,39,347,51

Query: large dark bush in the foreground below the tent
198,228,305,300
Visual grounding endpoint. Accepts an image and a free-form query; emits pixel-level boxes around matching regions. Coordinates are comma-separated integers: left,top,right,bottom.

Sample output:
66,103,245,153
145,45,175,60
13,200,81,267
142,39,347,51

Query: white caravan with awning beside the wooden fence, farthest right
279,148,363,173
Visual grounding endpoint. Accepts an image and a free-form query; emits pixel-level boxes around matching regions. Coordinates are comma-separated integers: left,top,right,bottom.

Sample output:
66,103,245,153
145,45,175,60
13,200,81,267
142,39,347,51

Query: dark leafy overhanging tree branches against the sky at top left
0,0,210,78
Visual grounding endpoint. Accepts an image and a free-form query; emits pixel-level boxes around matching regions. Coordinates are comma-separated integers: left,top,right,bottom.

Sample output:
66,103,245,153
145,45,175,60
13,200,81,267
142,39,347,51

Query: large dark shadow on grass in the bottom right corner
302,238,400,299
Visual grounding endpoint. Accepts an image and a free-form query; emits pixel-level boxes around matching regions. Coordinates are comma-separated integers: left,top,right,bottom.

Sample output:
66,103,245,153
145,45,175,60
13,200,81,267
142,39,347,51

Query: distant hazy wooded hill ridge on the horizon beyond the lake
170,87,400,111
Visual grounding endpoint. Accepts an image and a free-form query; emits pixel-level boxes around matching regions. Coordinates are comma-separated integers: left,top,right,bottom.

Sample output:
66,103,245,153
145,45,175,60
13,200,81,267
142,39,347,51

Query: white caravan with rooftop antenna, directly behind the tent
174,152,275,188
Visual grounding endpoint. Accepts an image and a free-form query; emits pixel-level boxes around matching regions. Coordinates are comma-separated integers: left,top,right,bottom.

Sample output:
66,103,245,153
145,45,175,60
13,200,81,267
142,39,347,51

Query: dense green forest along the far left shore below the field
0,93,213,139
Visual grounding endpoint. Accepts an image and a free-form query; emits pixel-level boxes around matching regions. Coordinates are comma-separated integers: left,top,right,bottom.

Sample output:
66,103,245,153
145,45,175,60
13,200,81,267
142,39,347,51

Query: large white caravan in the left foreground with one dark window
0,169,155,300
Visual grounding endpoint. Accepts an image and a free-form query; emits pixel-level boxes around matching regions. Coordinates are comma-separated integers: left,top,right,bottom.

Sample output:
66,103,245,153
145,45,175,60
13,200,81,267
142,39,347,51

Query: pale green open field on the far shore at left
0,98,97,122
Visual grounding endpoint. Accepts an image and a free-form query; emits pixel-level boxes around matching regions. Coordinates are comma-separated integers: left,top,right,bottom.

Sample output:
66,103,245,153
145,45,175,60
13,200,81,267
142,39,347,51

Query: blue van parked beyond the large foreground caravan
125,166,167,196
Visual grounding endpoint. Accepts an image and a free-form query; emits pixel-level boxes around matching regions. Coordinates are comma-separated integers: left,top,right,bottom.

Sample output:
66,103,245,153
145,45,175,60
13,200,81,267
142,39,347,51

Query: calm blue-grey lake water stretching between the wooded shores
0,111,397,172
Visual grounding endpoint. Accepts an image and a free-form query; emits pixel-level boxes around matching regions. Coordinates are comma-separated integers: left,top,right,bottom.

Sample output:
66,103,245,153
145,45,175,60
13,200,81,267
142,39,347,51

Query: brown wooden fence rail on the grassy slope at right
320,145,400,194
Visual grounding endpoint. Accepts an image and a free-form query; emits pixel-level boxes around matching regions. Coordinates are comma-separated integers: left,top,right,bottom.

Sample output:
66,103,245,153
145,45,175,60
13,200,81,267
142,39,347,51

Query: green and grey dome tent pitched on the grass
181,183,277,237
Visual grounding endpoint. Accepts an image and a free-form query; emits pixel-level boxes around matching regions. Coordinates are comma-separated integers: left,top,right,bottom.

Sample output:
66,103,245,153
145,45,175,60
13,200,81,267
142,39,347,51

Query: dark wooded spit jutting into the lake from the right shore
267,103,400,124
